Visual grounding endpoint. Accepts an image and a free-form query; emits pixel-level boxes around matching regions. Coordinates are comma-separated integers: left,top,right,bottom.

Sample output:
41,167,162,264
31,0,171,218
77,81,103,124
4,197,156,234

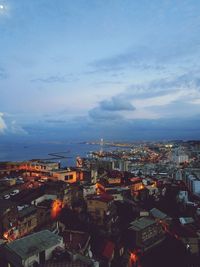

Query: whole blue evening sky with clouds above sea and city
0,0,200,141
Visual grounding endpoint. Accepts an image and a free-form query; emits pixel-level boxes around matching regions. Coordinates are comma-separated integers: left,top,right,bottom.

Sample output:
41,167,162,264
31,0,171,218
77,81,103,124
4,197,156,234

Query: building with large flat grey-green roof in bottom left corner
3,230,64,267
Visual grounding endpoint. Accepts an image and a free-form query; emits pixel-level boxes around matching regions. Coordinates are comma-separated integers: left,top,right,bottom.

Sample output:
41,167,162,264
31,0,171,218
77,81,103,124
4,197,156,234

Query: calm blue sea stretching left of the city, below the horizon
0,142,100,167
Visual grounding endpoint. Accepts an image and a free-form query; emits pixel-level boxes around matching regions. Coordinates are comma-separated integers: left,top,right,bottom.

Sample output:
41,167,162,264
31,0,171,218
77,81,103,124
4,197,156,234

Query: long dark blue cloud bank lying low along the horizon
0,112,200,142
